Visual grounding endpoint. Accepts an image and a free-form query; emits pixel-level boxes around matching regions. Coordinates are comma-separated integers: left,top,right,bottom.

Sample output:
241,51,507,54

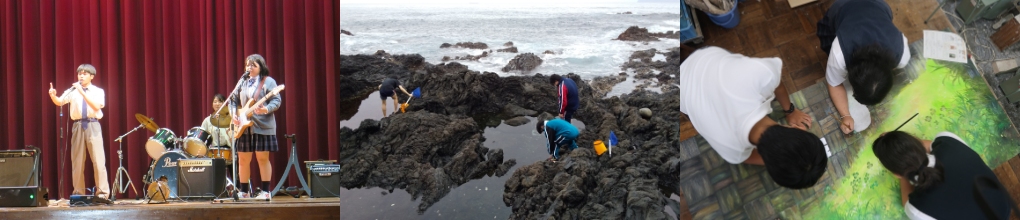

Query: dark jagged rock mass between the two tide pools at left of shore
340,111,516,214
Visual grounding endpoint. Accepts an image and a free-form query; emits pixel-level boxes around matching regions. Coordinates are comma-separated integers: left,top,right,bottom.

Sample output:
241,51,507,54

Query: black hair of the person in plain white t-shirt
758,125,828,189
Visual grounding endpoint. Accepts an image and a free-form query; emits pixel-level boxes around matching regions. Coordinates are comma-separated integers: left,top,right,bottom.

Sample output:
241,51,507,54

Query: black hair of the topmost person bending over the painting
847,44,898,105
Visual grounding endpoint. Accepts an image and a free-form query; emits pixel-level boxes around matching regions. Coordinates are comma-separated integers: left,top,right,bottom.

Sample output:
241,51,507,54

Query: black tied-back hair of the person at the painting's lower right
871,130,944,190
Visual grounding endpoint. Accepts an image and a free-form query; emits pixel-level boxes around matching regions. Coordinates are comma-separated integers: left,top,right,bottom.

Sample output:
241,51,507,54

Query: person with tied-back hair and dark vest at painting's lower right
871,131,1010,219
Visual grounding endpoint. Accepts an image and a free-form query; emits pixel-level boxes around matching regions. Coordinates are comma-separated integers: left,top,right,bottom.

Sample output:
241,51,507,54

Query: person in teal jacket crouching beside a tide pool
534,118,579,162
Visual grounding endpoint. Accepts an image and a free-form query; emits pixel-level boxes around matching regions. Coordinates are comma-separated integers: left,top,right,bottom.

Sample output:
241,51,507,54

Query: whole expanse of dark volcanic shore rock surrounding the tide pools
341,43,690,219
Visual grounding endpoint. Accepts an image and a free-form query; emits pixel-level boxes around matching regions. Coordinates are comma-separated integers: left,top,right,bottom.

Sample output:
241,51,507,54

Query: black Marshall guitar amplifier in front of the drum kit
177,158,226,200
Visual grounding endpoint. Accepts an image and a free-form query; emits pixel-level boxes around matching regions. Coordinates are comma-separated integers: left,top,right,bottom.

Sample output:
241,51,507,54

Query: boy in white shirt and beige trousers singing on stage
49,64,112,204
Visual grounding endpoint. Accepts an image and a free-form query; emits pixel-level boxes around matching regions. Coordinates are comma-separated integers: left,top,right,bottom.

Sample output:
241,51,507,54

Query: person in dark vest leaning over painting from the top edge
816,0,910,133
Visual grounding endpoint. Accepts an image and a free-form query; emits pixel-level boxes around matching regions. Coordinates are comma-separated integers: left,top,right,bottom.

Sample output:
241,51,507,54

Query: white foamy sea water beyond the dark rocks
340,2,680,83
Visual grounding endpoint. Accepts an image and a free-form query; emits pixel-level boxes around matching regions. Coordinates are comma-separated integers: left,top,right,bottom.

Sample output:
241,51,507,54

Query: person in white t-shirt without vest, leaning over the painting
676,47,828,188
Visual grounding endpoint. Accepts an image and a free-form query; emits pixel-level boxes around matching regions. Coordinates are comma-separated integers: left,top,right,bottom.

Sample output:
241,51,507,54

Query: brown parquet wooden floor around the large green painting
680,0,1020,220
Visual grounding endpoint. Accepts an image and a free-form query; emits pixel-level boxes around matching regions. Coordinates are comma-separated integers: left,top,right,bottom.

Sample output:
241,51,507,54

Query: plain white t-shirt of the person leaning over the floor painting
676,47,782,164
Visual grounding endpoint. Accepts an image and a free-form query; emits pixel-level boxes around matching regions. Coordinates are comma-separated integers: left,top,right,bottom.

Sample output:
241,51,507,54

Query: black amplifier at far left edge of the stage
0,150,41,187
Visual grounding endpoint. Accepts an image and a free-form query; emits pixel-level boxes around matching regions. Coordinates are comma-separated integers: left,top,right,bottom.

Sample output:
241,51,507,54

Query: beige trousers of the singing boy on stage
70,121,110,198
